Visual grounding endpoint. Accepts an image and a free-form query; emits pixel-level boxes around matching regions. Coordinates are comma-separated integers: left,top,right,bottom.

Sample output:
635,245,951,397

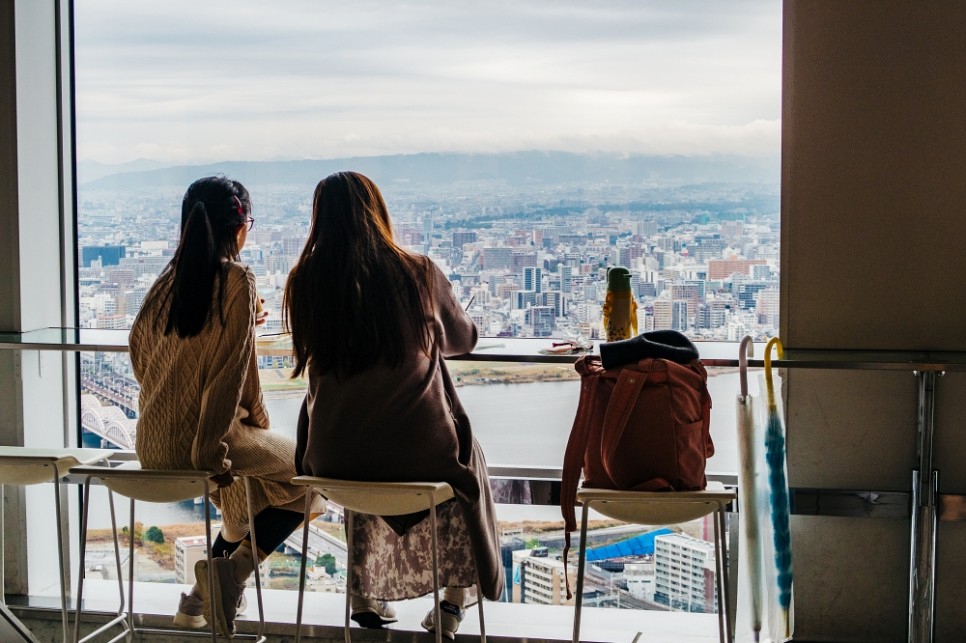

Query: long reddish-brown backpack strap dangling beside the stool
560,357,600,599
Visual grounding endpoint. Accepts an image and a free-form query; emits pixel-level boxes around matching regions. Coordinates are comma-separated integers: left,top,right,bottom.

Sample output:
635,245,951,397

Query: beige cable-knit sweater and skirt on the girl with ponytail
130,263,324,541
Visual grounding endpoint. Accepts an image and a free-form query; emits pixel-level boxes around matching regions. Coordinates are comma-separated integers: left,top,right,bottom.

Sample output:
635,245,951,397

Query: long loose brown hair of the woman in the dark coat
283,172,432,377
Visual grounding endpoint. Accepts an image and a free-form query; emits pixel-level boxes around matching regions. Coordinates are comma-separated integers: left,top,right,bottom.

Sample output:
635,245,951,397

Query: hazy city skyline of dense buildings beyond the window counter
78,175,780,341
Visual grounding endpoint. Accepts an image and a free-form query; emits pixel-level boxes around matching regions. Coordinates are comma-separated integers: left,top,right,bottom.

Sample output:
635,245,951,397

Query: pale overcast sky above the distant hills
75,0,781,163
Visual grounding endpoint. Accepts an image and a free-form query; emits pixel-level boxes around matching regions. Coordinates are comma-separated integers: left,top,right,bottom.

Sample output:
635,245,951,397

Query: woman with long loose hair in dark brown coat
284,172,503,639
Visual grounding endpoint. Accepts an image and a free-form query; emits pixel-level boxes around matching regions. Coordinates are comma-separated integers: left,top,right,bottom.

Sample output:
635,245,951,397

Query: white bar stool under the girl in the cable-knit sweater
70,462,266,643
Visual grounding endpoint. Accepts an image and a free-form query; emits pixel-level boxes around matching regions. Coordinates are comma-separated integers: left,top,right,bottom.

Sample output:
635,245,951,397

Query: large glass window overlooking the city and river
75,0,781,624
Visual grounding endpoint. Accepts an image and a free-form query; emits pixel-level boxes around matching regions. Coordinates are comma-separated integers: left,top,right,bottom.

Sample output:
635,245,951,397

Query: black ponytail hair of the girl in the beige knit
145,176,251,338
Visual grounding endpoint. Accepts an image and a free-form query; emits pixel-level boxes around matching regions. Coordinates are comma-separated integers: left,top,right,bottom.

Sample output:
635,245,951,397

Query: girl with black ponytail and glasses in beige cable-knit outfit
130,176,323,636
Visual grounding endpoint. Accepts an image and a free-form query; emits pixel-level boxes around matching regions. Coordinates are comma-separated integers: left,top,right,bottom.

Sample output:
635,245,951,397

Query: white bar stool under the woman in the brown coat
292,476,486,643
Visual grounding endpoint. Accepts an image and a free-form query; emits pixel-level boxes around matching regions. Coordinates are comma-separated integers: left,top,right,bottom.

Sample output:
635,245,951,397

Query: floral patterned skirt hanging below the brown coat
350,499,476,601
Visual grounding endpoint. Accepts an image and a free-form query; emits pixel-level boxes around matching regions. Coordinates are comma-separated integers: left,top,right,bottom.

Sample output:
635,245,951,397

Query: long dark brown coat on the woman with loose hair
296,260,503,600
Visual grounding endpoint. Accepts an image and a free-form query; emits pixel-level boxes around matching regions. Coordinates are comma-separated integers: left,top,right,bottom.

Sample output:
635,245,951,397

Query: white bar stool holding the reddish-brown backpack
573,488,737,643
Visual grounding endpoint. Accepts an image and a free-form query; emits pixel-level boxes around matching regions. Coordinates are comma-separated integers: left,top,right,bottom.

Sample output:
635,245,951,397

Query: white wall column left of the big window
0,0,74,594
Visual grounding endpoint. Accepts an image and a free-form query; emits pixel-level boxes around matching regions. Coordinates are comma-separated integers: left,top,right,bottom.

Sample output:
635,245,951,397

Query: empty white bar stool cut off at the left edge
0,446,112,643
